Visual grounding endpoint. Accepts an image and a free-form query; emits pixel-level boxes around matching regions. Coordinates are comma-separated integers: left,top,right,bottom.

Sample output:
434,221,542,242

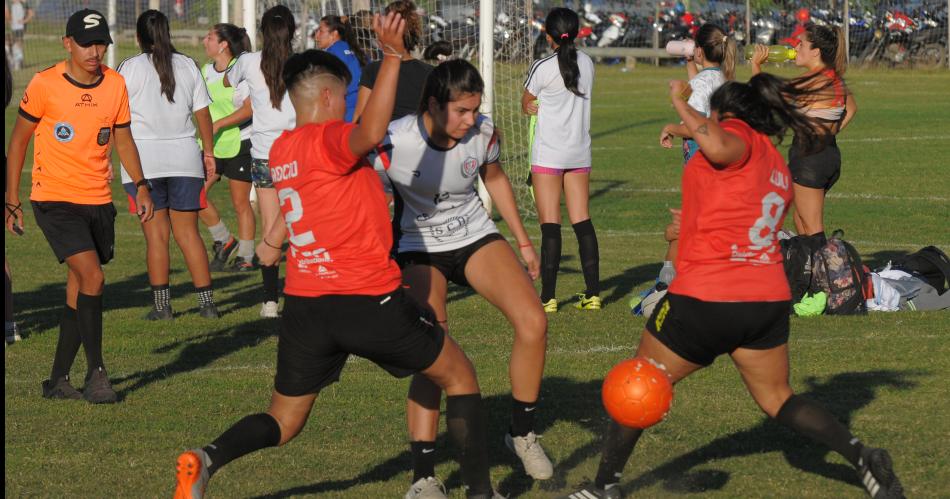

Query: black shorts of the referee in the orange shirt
31,201,116,265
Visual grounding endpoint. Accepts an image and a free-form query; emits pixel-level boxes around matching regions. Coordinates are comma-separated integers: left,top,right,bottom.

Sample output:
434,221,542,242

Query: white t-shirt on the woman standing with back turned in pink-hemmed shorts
524,52,594,169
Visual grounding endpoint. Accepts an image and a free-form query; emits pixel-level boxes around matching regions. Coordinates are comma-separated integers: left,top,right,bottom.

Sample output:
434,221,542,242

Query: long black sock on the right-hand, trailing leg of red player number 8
775,395,864,466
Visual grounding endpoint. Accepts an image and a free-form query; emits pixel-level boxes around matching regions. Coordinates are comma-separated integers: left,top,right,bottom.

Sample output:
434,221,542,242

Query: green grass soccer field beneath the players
4,65,950,498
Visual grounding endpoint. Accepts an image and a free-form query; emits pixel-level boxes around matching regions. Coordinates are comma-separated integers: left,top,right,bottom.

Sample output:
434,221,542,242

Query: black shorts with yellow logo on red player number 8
646,293,789,366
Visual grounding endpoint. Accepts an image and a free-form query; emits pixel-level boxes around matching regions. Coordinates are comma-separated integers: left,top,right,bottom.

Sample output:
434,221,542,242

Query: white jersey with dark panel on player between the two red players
370,114,501,253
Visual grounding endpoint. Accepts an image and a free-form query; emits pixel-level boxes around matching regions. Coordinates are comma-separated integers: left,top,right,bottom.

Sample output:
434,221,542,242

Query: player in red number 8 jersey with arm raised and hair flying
568,73,903,499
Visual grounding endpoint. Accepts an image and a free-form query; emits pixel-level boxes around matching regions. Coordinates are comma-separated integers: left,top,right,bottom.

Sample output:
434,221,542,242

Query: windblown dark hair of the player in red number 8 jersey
709,73,820,151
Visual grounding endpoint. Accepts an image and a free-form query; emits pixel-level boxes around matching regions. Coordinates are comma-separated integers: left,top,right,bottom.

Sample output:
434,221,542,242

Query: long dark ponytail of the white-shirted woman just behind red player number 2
261,5,297,111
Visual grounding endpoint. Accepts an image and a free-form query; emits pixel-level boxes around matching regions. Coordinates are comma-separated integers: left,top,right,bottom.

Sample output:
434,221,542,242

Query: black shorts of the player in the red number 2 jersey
274,287,445,397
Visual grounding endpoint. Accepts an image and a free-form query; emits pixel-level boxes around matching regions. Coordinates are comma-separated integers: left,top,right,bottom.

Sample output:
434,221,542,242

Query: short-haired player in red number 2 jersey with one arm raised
175,14,494,498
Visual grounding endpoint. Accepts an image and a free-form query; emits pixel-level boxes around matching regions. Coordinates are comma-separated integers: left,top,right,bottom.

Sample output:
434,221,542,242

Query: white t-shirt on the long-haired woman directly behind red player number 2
228,52,297,160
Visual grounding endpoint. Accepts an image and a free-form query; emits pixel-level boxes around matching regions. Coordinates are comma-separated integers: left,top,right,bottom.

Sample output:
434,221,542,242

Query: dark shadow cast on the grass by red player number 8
623,370,929,494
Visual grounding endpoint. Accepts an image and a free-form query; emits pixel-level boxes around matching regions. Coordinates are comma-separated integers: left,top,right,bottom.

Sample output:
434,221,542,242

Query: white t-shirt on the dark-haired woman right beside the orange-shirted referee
118,54,211,183
